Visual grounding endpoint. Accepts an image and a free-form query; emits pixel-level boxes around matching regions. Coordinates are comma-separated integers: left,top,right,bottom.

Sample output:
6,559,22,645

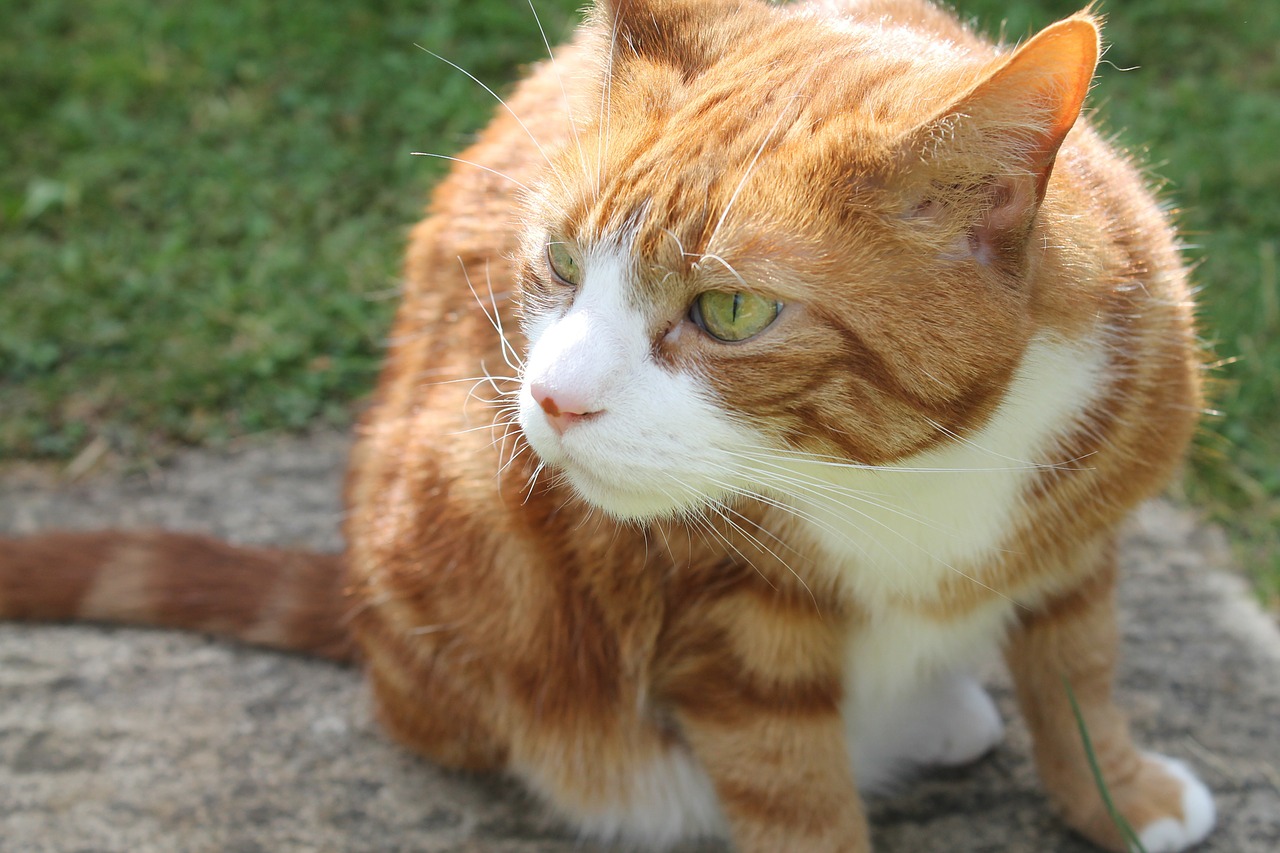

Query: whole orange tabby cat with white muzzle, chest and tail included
0,0,1213,852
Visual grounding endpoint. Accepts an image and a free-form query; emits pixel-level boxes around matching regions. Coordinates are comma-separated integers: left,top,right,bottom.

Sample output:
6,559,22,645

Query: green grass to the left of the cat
0,0,575,457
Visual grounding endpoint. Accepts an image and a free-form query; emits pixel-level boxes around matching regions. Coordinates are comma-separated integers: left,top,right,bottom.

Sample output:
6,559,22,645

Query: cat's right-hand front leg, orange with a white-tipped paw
1006,546,1213,853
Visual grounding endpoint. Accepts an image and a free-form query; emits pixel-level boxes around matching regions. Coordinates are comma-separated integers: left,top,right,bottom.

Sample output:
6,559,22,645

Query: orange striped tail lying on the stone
0,530,353,661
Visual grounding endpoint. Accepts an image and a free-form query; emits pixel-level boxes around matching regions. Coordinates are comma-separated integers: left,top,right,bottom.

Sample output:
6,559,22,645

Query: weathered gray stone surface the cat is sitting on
0,435,1280,853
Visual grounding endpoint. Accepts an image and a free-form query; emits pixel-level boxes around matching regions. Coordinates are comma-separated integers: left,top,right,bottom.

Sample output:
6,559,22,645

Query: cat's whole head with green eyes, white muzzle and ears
518,0,1098,519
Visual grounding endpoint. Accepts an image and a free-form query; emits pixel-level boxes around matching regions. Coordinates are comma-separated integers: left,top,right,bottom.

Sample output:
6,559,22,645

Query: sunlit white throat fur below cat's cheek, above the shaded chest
765,327,1106,603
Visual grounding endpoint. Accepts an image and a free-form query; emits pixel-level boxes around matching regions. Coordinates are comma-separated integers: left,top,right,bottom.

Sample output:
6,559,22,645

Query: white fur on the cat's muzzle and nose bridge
520,246,753,519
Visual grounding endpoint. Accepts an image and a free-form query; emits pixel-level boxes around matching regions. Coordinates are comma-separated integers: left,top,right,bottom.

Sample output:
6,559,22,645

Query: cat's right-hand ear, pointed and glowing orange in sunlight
908,13,1100,254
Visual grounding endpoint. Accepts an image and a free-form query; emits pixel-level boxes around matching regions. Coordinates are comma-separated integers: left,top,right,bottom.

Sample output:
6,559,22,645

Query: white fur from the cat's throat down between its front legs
808,330,1106,789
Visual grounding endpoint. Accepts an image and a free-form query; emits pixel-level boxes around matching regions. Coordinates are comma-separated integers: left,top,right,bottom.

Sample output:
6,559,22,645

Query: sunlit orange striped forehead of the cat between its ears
545,22,972,256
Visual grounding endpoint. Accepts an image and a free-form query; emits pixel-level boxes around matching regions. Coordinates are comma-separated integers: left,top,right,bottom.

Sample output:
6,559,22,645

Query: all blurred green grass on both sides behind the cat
0,0,1280,596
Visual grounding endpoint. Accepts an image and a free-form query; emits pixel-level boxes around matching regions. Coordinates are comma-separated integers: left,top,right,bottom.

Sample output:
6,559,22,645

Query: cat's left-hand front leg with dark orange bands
668,593,870,853
